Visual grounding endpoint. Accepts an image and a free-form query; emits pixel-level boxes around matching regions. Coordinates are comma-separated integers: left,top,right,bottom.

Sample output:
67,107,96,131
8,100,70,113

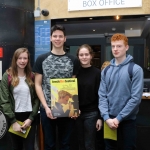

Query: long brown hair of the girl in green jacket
7,48,34,87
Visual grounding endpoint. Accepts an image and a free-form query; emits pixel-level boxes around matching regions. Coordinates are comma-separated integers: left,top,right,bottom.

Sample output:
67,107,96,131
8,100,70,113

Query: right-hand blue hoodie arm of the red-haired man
114,67,143,123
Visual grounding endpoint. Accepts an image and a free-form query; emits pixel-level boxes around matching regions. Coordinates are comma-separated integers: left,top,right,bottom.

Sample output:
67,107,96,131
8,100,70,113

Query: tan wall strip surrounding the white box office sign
35,0,150,20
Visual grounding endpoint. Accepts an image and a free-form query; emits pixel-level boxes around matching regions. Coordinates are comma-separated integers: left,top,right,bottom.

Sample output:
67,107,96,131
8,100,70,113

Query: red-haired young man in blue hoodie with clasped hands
99,33,143,150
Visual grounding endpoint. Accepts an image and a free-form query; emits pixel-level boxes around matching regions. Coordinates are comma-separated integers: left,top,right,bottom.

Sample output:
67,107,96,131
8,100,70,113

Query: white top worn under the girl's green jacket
13,76,32,112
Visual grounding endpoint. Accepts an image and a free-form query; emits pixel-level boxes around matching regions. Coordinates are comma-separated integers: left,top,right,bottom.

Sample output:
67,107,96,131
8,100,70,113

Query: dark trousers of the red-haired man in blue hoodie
105,120,137,150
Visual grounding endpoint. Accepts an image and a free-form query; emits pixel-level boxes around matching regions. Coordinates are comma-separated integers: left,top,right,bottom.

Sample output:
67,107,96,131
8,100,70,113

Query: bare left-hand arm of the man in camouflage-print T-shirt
35,73,54,119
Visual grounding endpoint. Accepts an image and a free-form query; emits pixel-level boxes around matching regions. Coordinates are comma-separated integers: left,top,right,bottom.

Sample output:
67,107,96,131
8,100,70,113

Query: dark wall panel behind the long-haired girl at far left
0,0,34,72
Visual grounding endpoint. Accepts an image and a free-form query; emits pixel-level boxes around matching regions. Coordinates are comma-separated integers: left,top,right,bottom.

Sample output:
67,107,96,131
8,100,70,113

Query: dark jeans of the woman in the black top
76,111,98,150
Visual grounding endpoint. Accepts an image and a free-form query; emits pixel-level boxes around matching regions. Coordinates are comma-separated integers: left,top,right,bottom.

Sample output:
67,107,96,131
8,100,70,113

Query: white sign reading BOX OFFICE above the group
68,0,142,11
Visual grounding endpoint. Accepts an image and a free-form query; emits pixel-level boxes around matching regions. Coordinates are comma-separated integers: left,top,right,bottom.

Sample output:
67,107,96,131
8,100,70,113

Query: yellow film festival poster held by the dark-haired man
50,78,79,117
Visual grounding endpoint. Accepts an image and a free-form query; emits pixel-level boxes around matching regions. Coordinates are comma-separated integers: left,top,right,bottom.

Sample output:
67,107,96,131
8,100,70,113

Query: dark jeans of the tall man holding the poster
40,107,75,150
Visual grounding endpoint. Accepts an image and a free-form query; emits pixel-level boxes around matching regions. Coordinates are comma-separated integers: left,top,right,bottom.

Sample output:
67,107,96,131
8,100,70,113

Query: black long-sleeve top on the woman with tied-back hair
77,66,101,112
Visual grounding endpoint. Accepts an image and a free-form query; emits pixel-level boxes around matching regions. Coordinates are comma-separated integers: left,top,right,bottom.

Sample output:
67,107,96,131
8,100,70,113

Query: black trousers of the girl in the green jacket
10,112,36,150
